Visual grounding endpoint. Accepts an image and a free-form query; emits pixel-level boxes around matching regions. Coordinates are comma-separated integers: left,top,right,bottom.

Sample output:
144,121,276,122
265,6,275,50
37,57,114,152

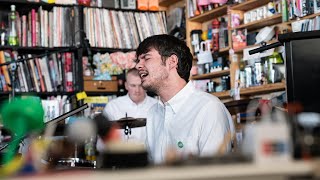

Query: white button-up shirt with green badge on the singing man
147,82,234,164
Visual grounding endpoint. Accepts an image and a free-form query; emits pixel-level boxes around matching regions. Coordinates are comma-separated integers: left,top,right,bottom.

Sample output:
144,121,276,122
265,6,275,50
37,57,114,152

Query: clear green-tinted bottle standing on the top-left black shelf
8,5,19,46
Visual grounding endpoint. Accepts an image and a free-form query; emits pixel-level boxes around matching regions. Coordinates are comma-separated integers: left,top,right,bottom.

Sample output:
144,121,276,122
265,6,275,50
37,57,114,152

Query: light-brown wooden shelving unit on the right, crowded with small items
181,0,320,117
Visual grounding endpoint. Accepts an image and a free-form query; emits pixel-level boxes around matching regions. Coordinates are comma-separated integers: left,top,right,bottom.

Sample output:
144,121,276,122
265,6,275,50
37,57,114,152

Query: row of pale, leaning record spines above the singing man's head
83,7,167,49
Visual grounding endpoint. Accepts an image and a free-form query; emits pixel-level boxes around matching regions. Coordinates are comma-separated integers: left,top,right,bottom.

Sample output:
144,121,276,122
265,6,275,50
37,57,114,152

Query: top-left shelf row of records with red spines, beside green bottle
0,5,79,47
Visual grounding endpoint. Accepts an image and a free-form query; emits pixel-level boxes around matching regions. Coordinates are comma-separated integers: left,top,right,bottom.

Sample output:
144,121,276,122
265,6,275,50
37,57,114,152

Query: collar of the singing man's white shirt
165,81,195,113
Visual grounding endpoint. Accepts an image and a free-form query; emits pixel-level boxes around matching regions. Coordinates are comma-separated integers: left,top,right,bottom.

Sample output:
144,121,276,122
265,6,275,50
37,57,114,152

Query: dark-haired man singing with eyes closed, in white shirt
136,34,234,164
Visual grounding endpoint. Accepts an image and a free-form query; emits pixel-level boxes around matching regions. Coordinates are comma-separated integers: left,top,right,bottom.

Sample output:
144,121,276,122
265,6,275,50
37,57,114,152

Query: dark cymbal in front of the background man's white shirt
114,117,147,129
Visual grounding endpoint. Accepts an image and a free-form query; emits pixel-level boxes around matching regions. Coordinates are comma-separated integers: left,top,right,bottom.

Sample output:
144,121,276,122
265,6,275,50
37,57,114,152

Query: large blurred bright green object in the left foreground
1,98,45,163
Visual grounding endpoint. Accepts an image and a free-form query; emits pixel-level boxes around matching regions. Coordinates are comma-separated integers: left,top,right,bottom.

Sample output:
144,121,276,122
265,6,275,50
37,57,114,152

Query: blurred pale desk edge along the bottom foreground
12,161,320,180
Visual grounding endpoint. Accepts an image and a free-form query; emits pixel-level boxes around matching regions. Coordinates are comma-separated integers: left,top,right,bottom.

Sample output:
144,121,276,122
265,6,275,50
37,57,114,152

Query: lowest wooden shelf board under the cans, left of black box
240,82,286,96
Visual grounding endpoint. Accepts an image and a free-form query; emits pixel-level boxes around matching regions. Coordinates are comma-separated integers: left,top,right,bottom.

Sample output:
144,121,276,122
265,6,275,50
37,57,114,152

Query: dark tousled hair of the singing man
136,34,193,82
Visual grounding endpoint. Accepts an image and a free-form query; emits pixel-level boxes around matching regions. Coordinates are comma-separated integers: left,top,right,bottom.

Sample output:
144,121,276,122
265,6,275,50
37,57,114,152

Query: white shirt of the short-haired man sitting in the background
103,94,157,143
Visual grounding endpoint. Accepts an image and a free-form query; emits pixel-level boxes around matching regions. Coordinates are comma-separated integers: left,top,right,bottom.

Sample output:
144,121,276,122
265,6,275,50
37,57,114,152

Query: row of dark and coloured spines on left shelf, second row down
0,50,77,93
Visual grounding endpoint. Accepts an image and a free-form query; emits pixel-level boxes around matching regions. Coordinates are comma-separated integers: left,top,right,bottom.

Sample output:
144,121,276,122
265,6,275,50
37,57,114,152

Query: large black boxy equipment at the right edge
279,31,320,113
